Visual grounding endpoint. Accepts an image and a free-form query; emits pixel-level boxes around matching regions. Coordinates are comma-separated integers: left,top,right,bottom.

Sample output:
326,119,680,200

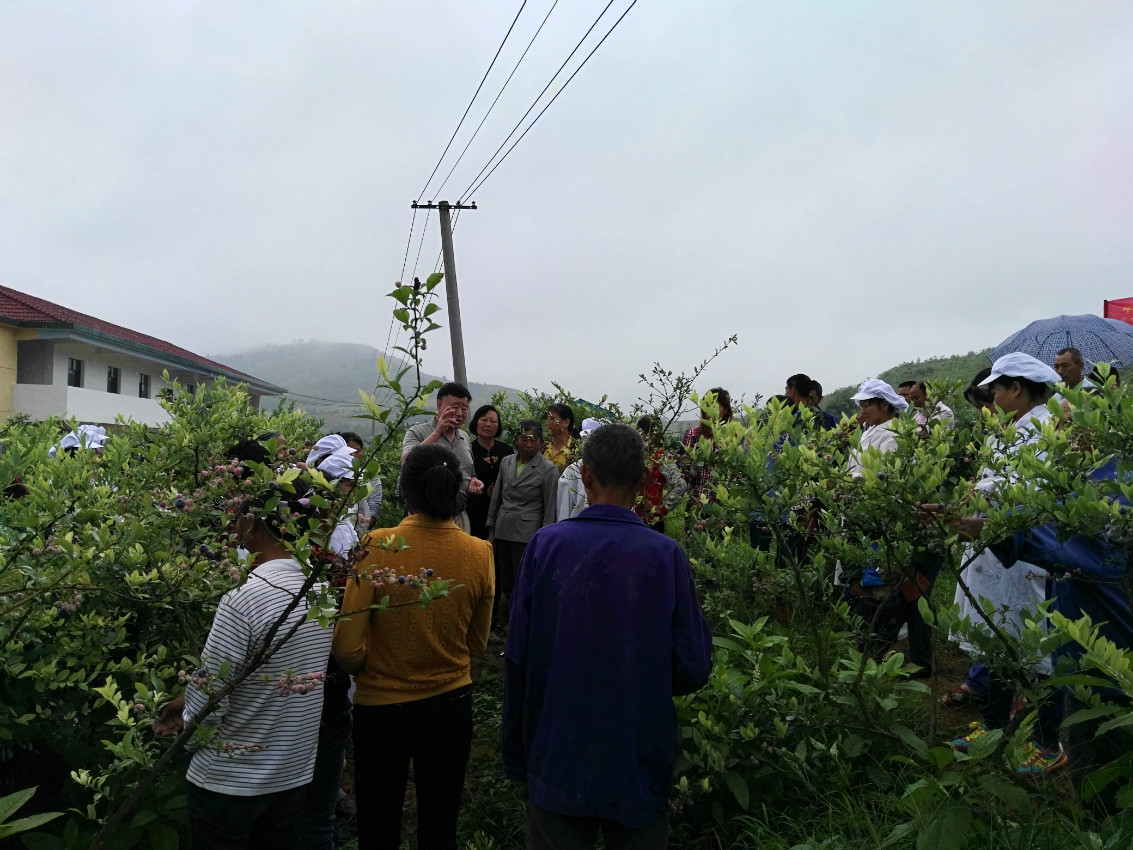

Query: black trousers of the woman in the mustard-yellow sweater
353,685,472,850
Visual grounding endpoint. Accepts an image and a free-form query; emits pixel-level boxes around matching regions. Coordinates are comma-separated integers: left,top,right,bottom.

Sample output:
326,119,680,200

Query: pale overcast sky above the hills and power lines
0,0,1133,410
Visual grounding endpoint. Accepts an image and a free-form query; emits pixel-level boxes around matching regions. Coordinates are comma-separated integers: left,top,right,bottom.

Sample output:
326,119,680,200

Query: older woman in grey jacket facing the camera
487,419,559,629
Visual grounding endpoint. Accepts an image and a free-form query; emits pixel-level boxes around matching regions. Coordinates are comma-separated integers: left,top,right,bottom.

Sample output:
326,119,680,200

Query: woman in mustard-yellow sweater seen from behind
332,443,495,850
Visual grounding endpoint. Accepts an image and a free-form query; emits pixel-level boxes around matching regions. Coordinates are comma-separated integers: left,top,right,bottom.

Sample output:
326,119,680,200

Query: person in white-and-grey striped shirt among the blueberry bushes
154,478,332,850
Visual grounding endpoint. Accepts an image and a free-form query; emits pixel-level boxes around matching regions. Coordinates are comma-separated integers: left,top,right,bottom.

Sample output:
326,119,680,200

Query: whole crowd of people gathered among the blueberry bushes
60,342,1133,849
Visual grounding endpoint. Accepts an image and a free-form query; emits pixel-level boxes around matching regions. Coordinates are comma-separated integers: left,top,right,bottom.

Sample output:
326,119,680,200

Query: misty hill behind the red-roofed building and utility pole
210,340,516,436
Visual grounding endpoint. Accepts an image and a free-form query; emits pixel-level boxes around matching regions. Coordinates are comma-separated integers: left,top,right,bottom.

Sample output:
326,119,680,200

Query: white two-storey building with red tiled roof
0,287,287,425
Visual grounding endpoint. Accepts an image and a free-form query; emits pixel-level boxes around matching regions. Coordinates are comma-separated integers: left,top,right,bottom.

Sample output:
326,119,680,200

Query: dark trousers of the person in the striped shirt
188,783,307,850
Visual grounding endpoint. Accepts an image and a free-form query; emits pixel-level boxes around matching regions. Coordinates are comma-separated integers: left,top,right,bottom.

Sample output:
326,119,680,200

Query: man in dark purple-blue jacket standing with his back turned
503,425,712,848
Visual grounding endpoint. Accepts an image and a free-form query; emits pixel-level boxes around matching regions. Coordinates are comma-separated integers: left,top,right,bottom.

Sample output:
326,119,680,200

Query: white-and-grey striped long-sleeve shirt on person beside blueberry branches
185,560,331,797
